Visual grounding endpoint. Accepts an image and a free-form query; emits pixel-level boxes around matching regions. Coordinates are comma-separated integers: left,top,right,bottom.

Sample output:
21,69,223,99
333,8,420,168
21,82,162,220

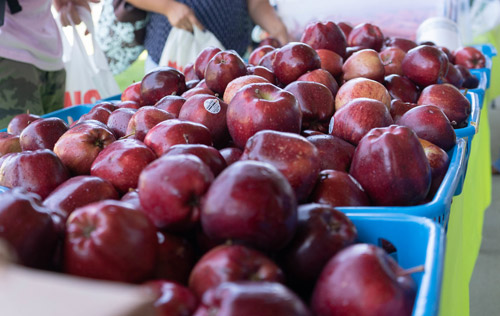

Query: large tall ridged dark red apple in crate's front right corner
349,125,431,206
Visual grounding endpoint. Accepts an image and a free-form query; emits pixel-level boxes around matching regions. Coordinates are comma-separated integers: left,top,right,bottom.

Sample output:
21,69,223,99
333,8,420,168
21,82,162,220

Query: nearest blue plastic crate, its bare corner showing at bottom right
347,214,445,316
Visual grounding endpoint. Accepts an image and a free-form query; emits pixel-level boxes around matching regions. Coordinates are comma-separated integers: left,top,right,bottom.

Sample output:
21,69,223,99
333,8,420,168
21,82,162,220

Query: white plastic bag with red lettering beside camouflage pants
61,8,120,107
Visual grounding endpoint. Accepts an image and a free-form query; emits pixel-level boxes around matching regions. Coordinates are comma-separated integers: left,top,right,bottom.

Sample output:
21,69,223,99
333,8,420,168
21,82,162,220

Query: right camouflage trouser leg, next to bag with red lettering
42,69,66,113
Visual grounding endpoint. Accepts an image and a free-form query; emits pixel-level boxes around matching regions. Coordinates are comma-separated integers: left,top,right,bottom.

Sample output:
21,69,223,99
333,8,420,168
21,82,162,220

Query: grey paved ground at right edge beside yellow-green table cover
469,99,500,316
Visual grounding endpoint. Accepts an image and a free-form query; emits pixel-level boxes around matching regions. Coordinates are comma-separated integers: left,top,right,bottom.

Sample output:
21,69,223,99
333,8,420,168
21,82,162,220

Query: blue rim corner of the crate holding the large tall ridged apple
338,138,466,228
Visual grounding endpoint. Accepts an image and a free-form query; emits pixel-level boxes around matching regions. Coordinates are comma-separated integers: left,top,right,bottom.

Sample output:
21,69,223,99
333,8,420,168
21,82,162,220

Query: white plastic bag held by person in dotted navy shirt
159,26,224,71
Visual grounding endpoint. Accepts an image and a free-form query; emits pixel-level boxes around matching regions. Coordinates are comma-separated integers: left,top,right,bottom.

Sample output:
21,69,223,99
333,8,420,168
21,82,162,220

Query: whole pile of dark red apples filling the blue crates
0,22,484,316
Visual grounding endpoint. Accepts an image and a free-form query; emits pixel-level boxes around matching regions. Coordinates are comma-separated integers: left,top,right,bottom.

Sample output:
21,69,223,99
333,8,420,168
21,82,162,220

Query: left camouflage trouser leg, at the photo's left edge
0,58,44,129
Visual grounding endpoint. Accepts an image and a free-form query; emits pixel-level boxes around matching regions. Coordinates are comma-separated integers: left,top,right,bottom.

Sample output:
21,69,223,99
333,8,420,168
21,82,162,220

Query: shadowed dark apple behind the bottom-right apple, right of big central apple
282,203,358,294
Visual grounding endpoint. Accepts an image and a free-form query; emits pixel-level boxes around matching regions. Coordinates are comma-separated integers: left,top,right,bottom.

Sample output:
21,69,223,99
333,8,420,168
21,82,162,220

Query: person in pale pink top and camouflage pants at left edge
0,0,99,128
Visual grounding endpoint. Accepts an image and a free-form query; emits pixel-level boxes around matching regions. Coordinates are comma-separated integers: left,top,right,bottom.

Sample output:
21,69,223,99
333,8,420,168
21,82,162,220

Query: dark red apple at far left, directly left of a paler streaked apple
19,117,68,150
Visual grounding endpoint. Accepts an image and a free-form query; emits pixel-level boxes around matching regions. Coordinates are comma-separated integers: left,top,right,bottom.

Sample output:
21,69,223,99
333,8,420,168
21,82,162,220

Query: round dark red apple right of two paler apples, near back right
402,45,448,87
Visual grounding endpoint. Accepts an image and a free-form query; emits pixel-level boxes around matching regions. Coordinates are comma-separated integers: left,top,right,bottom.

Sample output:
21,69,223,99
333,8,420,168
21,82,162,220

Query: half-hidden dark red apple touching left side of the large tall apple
307,134,355,171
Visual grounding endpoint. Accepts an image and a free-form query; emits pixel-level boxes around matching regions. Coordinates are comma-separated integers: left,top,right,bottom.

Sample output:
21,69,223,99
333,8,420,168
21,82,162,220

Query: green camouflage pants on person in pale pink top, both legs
0,57,66,129
